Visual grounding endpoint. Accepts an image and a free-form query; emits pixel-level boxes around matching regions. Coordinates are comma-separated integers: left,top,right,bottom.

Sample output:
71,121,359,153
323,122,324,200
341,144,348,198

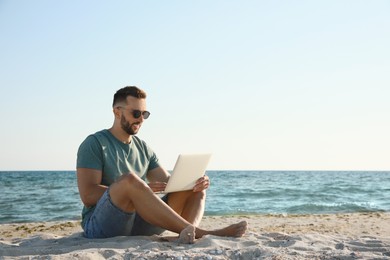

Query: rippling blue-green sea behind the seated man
0,171,390,224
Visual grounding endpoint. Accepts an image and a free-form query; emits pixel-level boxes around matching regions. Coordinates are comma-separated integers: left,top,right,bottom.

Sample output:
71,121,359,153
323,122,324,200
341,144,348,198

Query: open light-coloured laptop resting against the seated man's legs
162,153,211,193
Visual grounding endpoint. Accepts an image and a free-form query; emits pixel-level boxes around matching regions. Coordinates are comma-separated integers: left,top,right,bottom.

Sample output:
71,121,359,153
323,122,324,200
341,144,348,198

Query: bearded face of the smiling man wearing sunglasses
119,96,146,135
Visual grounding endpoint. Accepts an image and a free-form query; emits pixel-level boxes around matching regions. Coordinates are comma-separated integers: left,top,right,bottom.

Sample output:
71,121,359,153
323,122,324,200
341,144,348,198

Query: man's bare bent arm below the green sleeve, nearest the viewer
77,168,108,207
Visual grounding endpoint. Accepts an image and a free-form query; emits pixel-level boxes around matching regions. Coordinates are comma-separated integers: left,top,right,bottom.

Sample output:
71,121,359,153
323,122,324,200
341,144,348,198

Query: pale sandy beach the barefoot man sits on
0,212,390,259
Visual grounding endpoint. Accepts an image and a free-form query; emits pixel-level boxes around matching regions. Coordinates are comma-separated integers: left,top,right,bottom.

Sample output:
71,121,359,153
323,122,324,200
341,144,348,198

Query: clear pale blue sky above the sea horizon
0,0,390,171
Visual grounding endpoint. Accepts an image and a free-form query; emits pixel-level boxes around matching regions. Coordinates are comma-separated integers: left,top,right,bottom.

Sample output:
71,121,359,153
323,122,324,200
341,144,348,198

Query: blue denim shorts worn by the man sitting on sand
83,190,168,238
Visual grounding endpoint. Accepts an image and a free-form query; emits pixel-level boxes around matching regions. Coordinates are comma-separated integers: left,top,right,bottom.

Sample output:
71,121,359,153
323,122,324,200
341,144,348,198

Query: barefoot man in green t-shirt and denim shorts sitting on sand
77,87,247,243
